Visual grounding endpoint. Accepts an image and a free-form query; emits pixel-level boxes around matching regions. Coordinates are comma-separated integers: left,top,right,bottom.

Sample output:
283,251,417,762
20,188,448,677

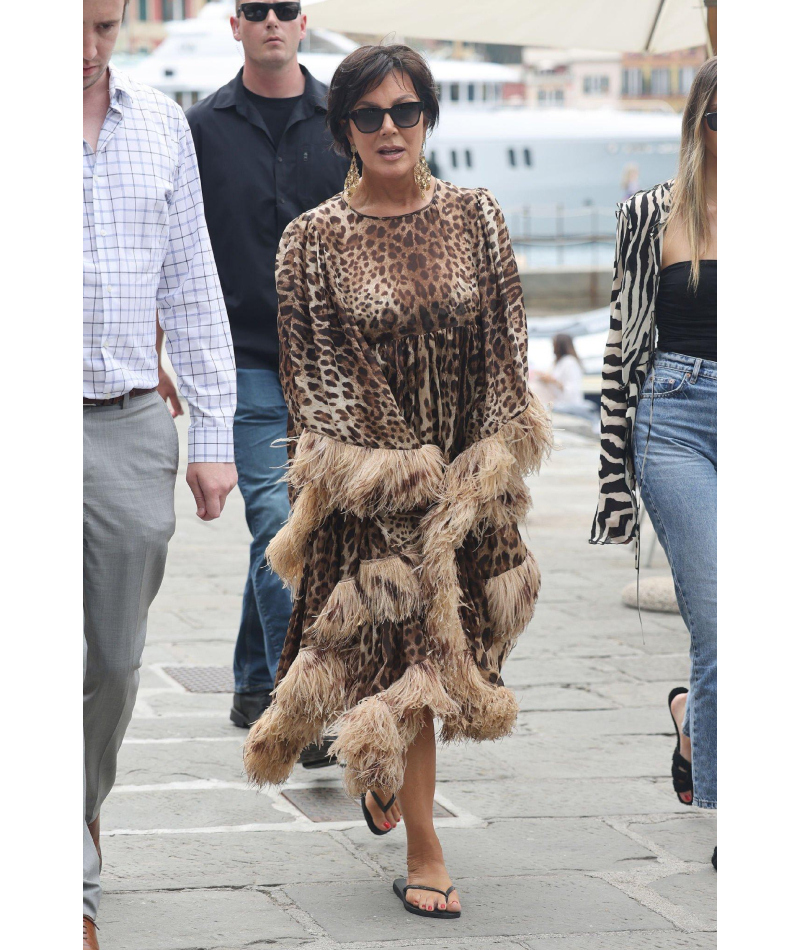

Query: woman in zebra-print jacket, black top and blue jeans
590,58,717,867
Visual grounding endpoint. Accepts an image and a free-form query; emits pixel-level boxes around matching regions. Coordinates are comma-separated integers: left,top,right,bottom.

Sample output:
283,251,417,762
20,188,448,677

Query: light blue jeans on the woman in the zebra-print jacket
634,350,717,808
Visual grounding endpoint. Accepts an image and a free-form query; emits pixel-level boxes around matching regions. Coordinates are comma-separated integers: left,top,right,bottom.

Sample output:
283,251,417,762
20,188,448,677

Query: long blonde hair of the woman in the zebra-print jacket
667,56,717,290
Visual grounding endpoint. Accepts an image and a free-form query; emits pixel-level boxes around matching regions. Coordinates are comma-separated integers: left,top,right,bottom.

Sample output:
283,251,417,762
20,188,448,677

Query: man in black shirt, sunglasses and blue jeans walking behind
186,3,348,744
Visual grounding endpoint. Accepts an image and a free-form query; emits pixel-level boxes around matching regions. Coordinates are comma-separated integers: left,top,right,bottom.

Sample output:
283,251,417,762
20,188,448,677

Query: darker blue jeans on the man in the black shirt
233,369,292,693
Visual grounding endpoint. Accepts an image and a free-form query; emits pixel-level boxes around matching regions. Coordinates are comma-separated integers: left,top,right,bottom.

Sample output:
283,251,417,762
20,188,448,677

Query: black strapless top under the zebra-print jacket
656,261,717,362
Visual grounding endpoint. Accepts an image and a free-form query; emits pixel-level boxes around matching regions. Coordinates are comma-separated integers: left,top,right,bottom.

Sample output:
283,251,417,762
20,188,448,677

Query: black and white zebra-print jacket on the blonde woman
589,181,673,544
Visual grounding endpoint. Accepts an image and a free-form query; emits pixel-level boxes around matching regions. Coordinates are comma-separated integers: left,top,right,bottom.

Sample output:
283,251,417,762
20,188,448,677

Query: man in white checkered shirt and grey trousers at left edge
83,0,236,948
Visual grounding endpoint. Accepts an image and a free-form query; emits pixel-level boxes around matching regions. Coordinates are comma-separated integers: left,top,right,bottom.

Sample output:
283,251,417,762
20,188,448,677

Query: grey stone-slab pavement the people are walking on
100,417,716,950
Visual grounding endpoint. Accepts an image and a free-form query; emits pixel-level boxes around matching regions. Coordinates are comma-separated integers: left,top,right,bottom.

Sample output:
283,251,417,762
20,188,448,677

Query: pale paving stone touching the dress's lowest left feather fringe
117,732,245,785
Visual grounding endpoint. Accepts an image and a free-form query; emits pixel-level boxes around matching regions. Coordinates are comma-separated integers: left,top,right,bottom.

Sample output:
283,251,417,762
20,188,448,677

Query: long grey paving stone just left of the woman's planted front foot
102,831,374,891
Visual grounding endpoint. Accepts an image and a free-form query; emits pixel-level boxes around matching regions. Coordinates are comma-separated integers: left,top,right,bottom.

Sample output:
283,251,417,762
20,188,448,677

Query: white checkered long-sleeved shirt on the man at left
83,68,236,462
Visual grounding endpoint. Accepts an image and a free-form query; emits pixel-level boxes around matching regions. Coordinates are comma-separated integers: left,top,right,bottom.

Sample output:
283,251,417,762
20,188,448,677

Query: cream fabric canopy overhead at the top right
303,0,708,53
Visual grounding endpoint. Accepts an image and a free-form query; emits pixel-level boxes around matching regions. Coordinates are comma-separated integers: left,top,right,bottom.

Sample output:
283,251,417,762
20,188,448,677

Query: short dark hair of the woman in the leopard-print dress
327,43,439,155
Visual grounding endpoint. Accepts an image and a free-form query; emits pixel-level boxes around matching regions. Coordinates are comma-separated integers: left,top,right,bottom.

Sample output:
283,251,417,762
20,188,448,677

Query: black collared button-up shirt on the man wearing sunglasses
186,66,349,371
